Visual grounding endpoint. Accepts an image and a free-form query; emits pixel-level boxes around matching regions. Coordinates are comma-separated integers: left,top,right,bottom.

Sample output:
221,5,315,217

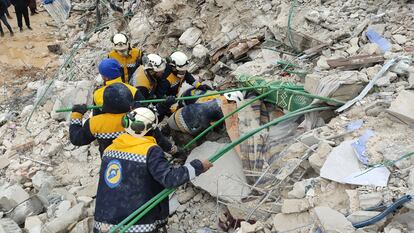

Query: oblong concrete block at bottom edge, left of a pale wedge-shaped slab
273,212,315,232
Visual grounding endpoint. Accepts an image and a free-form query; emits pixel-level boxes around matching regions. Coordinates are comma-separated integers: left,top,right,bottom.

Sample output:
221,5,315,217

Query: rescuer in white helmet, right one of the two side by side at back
161,51,212,96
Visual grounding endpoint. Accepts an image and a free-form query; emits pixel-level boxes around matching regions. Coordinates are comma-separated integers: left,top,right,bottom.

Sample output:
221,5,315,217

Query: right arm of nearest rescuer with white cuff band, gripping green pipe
147,146,208,188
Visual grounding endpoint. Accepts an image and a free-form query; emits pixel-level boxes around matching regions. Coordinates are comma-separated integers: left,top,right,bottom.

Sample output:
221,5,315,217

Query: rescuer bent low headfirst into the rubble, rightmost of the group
167,89,243,135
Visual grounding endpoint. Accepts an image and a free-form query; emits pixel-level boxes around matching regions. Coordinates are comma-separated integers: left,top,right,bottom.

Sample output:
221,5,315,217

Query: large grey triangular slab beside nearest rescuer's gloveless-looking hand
187,141,250,202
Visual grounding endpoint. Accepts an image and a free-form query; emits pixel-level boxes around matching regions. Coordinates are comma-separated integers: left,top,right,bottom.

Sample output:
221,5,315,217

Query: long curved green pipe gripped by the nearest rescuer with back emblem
110,106,334,233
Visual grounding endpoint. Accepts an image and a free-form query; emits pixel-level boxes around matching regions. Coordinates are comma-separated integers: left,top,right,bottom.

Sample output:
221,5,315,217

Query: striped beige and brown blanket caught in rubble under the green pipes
223,93,297,184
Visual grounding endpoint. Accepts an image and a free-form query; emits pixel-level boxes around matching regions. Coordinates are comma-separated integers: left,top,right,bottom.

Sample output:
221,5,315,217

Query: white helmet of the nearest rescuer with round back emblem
122,107,158,138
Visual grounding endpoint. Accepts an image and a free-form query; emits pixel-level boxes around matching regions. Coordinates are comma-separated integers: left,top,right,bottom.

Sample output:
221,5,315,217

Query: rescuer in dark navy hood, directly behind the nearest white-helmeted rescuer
69,83,185,158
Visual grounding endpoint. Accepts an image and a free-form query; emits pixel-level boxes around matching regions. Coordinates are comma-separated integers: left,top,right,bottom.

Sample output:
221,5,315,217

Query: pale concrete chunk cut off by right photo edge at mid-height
387,90,414,126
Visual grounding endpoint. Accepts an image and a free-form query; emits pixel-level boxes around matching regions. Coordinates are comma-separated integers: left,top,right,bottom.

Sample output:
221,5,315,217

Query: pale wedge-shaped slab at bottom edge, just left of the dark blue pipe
314,206,355,233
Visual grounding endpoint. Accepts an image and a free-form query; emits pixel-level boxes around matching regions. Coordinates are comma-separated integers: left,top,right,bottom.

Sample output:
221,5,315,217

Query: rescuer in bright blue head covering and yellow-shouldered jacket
93,58,144,115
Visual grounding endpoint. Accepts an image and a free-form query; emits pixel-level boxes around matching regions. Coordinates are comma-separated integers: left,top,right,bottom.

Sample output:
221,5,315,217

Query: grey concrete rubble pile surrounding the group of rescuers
0,0,414,233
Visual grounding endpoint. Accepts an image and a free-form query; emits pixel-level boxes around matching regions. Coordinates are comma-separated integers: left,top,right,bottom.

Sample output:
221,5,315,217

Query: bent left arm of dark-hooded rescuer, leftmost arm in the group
69,112,95,146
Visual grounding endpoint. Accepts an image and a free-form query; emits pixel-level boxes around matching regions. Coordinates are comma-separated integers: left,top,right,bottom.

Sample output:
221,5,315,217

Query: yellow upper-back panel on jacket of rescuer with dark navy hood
89,113,125,139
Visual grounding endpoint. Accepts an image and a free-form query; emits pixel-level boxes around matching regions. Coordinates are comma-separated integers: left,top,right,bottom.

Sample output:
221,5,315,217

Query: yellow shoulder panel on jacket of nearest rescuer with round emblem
105,133,157,156
